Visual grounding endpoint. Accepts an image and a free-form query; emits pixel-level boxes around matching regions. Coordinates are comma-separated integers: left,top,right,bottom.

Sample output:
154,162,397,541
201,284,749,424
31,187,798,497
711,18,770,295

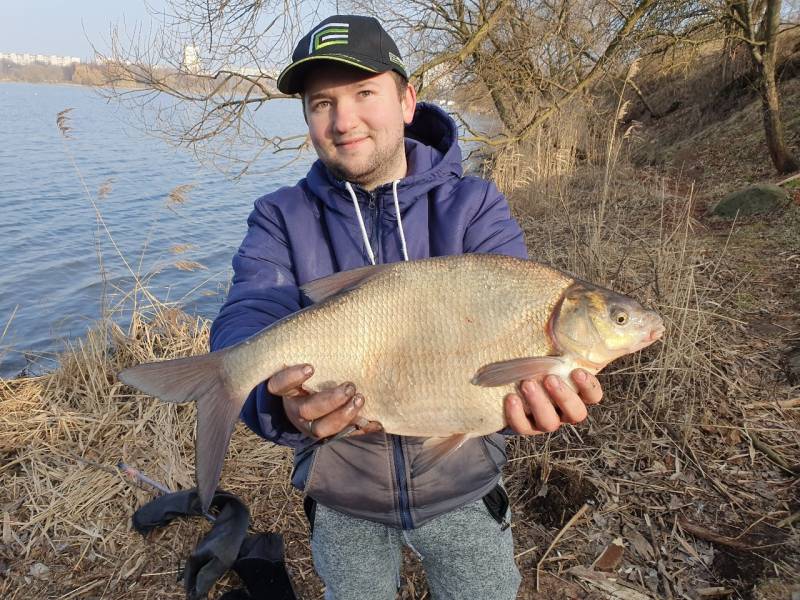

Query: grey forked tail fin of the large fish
118,350,250,512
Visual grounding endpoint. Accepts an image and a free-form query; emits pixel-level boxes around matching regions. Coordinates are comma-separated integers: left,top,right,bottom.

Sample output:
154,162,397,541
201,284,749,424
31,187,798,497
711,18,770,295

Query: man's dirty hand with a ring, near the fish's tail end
267,365,381,438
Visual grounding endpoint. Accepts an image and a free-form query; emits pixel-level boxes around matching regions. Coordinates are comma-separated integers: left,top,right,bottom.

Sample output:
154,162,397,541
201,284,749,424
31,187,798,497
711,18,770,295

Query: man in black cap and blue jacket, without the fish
211,15,602,600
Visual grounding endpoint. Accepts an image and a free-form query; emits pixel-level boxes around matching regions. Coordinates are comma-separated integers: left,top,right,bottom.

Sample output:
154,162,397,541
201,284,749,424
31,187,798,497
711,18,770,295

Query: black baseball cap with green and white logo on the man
278,15,408,94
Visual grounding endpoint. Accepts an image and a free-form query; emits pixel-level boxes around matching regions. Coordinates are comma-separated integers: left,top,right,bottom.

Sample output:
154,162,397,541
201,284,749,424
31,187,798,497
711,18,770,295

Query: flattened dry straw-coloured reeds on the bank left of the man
0,309,310,599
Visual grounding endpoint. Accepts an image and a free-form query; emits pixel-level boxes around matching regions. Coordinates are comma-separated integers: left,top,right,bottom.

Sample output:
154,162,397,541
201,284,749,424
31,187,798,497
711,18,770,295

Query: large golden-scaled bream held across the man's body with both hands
119,254,664,508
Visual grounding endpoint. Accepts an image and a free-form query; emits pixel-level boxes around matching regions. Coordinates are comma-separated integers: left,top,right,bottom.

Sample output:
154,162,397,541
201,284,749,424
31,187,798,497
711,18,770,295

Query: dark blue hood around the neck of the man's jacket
305,102,463,210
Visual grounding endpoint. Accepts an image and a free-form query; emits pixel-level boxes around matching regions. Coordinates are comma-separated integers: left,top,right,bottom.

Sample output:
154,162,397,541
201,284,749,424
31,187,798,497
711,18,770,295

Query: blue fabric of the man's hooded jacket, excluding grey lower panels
211,103,527,528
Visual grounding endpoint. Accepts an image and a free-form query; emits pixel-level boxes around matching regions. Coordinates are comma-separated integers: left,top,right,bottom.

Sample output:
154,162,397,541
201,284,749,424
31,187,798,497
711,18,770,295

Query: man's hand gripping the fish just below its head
505,369,603,435
